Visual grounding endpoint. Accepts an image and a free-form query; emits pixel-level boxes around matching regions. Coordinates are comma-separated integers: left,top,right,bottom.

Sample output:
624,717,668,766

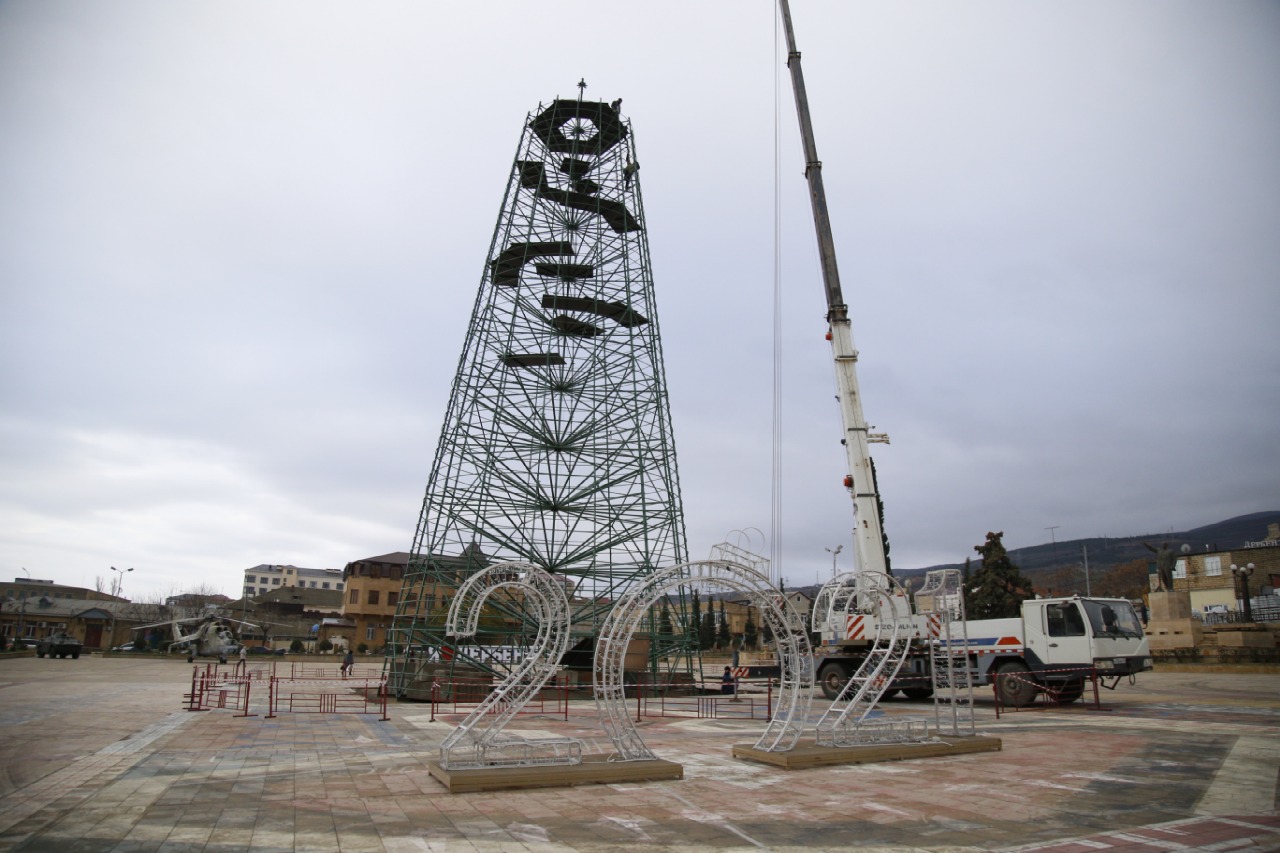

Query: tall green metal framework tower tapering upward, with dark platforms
392,83,687,686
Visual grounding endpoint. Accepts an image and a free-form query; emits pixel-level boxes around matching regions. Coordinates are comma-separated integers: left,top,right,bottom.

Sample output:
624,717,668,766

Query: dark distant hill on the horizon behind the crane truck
800,510,1280,594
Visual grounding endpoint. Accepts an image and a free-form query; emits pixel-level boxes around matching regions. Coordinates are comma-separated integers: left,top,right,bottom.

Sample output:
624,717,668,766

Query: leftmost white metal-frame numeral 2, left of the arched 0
440,562,582,770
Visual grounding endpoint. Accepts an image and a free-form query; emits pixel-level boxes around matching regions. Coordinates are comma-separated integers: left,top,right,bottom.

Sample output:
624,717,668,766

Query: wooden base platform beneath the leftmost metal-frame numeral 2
429,754,685,794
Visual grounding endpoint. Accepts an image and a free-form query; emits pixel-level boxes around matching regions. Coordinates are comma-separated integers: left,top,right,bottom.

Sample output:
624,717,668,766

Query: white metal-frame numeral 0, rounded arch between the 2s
594,560,813,761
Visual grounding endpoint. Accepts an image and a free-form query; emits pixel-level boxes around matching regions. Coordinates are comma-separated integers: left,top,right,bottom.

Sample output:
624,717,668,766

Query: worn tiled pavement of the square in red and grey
0,657,1280,853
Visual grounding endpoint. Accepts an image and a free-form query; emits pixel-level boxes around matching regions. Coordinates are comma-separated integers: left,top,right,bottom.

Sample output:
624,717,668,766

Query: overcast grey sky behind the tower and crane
0,0,1280,597
